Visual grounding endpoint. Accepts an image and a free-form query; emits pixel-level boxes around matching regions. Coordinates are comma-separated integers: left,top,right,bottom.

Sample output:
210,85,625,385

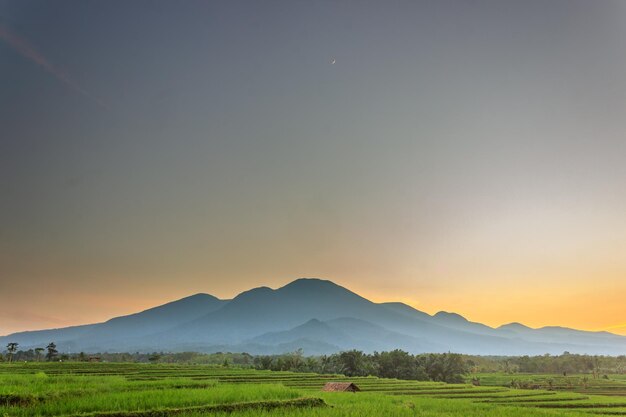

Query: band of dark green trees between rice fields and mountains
0,343,626,383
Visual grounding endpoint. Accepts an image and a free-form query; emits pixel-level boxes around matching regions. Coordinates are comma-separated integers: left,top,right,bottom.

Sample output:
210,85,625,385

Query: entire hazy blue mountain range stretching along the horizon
0,278,626,355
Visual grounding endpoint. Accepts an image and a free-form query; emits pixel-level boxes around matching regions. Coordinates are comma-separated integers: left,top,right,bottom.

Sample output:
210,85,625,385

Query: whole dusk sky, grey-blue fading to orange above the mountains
0,0,626,334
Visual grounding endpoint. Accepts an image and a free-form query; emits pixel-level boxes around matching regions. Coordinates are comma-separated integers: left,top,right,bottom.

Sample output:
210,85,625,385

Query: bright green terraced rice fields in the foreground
0,363,626,417
